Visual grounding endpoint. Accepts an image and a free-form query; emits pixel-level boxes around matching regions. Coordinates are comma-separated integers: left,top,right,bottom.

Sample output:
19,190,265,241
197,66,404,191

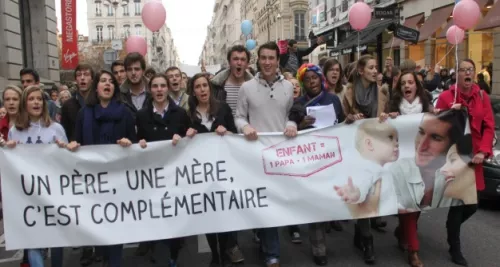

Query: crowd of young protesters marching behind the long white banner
0,37,494,267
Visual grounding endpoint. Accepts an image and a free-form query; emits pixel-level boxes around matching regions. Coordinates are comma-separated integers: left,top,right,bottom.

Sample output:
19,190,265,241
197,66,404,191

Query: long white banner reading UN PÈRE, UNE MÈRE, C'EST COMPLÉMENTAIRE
0,114,475,250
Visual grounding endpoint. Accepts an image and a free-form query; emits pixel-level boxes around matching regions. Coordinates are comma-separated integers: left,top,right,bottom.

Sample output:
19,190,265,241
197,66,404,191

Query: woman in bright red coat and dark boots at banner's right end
436,59,495,266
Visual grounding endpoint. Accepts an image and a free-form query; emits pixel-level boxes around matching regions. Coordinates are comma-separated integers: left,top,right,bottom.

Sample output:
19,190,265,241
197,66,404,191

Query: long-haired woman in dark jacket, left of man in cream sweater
186,73,243,266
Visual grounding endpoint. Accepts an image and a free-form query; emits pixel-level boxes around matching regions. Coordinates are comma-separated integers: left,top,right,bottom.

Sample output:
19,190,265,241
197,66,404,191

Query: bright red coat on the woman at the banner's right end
436,84,495,191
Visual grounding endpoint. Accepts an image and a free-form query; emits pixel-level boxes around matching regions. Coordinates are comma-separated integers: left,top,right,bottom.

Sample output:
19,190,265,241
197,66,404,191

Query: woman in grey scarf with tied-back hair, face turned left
343,55,389,264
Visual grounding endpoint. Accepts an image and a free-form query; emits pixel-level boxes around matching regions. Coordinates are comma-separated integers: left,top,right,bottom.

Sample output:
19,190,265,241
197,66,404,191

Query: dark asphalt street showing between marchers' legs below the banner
0,205,500,267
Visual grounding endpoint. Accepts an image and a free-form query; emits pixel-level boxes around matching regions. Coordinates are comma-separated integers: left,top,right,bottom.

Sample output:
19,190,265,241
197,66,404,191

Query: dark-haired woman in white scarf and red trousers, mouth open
380,71,434,267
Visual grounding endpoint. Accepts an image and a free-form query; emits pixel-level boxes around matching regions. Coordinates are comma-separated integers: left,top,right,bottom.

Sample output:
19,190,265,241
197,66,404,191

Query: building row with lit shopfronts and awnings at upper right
309,0,500,97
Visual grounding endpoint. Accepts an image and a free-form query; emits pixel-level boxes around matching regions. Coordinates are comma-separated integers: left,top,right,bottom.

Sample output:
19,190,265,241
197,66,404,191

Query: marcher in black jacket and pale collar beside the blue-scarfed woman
136,73,189,267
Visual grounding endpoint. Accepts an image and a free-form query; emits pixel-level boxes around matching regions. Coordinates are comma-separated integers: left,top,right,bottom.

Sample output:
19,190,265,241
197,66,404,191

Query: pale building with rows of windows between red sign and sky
87,0,180,71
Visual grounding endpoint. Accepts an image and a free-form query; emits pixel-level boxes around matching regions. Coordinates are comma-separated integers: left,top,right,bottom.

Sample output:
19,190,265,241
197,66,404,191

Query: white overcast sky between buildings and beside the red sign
55,0,215,65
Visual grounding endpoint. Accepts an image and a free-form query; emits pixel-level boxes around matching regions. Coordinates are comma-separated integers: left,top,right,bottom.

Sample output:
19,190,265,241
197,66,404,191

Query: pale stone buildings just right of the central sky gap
200,0,309,65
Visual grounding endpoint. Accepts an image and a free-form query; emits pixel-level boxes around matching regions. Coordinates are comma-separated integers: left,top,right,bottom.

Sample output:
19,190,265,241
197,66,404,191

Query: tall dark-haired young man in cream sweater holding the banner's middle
235,42,297,267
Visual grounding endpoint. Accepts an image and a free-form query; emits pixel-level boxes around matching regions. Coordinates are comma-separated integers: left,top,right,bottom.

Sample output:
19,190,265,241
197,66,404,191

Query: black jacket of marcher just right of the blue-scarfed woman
136,97,190,142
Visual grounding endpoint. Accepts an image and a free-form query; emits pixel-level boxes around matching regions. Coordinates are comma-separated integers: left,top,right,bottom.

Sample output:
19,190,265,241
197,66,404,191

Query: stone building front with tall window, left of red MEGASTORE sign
0,0,59,91
